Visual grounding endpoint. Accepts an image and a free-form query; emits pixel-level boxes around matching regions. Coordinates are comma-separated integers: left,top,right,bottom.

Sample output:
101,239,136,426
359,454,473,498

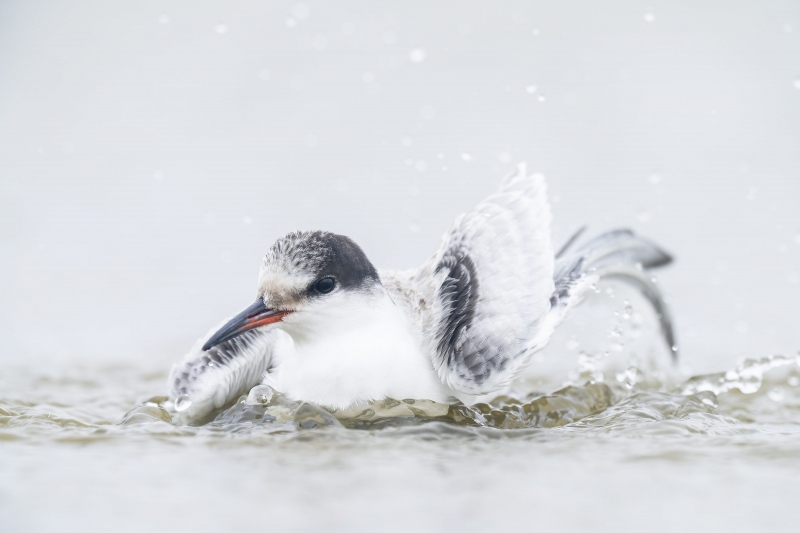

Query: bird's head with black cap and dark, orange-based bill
203,231,383,350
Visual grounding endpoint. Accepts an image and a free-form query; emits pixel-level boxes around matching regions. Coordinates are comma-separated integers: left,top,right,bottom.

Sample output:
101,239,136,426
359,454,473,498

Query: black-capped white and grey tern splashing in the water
167,164,677,422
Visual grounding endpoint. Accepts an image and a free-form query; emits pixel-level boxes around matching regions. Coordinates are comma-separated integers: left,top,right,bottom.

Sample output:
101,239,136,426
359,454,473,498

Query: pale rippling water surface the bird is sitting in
0,350,800,531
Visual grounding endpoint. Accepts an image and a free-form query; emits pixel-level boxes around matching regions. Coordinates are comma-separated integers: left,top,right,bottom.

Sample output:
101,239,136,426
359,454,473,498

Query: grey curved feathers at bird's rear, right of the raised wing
551,229,677,357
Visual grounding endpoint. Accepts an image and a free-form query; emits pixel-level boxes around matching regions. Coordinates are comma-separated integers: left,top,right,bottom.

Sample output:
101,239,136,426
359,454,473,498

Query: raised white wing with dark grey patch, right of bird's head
416,165,554,395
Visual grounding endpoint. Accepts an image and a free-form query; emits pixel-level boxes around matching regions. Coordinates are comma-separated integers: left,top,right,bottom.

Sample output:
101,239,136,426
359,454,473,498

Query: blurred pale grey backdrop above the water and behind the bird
0,0,800,373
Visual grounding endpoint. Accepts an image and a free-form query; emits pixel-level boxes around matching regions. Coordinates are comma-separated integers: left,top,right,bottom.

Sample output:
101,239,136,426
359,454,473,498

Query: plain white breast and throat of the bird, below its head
264,290,448,409
